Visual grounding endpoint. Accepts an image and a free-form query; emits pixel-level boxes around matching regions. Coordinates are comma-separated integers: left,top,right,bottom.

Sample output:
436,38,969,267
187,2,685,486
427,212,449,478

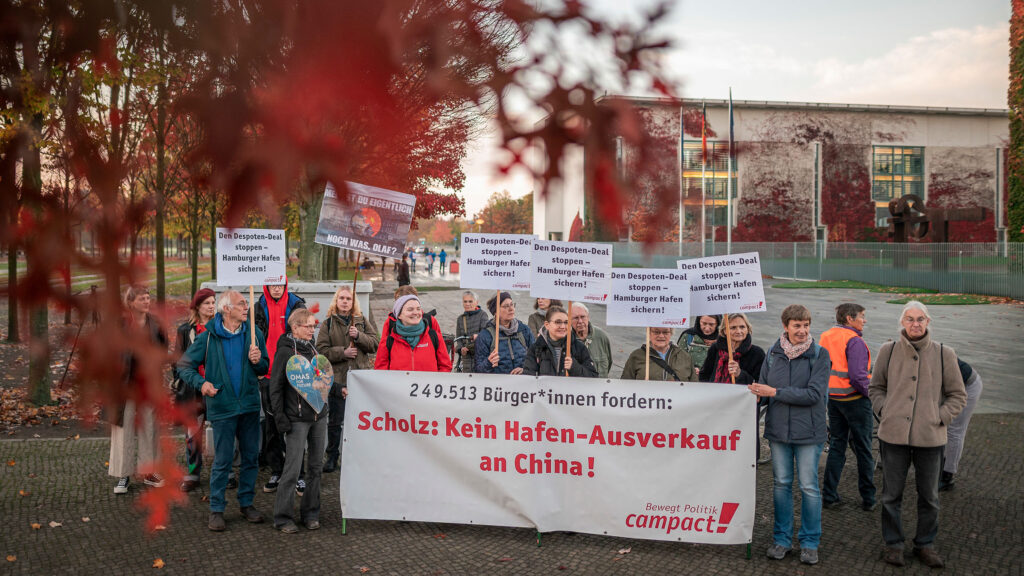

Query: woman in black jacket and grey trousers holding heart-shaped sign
269,308,330,534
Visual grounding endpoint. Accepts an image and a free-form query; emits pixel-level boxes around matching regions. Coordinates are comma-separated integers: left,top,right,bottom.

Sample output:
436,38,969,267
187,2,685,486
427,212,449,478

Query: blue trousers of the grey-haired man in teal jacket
210,412,259,512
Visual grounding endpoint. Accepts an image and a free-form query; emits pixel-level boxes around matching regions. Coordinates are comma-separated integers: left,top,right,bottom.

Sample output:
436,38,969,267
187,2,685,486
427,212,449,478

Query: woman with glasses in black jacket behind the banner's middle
522,305,597,378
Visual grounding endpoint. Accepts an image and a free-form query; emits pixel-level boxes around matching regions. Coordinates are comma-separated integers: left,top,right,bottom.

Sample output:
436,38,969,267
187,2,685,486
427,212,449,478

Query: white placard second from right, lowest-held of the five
607,269,690,328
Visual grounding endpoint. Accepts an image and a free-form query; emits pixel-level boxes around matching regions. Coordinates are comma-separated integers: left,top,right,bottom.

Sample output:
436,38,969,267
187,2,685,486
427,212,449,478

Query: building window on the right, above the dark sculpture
871,146,925,228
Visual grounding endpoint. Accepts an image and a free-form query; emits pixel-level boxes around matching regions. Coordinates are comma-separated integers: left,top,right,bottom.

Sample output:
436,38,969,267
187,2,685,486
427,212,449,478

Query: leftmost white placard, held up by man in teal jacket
216,228,287,286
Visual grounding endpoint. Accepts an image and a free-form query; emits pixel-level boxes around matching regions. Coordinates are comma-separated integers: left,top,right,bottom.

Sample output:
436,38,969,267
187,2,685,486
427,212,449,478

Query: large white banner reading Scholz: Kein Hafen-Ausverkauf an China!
341,370,757,544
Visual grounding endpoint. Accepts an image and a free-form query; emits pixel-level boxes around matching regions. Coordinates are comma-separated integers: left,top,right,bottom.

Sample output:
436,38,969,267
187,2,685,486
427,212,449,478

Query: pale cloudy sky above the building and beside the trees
454,0,1010,216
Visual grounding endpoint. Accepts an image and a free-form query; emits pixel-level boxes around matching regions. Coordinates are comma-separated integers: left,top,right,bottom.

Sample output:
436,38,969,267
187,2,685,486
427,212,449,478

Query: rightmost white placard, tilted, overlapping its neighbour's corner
676,252,768,318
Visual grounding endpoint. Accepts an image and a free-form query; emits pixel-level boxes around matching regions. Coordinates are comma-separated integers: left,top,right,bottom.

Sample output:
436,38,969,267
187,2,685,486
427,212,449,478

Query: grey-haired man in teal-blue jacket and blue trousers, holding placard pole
178,290,269,532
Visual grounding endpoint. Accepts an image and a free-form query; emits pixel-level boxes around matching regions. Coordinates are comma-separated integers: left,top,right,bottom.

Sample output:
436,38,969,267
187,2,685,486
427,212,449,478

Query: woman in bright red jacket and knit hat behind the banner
374,294,452,372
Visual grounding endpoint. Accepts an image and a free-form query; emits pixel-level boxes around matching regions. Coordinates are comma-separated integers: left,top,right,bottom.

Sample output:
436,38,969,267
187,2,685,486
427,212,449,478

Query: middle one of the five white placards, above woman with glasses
529,240,611,304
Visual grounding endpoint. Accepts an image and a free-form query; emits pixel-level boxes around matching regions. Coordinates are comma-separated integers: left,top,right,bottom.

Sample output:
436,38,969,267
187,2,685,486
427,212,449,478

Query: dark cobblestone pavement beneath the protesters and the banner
0,414,1024,576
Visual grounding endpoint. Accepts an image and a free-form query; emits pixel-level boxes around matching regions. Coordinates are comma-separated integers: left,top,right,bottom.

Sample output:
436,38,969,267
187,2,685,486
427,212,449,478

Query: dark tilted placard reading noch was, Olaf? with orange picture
314,182,416,258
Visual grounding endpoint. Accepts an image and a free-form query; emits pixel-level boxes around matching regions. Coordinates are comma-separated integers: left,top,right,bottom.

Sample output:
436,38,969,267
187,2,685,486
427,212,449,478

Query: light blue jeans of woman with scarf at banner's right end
771,441,824,549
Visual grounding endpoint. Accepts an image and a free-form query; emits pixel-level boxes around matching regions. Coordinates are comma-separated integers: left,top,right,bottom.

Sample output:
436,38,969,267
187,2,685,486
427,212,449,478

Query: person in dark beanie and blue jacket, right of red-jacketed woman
474,292,534,374
